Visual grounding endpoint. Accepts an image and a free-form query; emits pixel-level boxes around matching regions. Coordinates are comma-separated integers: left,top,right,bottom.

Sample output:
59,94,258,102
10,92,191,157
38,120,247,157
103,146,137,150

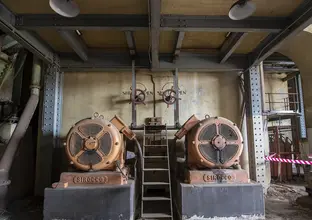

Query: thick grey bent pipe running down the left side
0,57,41,175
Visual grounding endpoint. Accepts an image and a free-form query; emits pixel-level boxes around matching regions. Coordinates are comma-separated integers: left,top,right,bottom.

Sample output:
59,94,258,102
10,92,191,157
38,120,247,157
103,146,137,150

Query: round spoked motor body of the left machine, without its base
65,117,124,171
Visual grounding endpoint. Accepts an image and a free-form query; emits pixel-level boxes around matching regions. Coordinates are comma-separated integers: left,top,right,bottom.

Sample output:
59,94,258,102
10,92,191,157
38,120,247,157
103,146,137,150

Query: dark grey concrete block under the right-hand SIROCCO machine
174,183,265,220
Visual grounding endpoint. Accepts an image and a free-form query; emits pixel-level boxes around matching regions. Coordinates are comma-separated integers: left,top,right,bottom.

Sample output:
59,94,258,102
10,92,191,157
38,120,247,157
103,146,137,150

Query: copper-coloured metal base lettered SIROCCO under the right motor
185,169,250,184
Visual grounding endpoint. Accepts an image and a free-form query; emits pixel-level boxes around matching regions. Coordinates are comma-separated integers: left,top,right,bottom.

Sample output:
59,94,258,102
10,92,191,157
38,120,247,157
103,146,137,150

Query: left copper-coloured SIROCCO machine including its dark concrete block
44,113,142,220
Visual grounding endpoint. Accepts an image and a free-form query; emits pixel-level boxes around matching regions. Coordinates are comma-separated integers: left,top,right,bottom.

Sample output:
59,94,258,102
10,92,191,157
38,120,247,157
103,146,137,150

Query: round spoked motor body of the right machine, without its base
187,117,243,168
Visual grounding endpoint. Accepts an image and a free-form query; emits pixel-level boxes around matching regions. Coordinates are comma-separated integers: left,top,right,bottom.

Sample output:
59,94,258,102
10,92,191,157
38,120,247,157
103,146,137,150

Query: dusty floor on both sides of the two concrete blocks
0,183,312,220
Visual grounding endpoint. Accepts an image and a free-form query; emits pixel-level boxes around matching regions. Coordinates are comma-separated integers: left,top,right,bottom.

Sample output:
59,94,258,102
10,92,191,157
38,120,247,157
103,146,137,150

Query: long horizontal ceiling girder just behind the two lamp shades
15,14,287,33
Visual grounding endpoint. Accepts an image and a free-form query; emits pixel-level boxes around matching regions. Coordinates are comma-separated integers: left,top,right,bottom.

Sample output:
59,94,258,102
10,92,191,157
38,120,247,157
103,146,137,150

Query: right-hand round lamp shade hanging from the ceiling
229,0,256,20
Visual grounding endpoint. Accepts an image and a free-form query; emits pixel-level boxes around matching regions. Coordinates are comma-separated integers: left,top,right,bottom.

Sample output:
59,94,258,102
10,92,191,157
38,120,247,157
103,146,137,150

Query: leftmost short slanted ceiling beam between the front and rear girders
58,30,88,61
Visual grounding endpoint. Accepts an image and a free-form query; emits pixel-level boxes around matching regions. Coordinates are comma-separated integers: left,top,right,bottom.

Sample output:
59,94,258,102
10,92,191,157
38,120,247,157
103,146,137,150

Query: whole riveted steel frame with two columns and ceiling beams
0,0,312,191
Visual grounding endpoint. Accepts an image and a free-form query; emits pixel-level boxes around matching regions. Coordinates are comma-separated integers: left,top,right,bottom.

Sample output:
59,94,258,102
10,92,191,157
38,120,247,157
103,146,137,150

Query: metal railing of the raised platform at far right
264,93,300,112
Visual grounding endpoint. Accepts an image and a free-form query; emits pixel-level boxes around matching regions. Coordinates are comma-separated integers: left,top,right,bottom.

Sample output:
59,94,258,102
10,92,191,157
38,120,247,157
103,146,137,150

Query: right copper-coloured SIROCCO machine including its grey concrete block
173,115,264,219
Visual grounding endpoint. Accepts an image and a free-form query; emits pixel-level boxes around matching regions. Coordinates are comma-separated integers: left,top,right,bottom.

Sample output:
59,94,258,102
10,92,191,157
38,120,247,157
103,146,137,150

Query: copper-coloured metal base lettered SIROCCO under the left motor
52,171,128,188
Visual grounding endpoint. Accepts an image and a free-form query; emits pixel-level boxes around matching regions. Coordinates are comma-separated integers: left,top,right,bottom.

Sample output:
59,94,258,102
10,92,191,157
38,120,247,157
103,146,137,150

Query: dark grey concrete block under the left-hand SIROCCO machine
43,180,135,220
